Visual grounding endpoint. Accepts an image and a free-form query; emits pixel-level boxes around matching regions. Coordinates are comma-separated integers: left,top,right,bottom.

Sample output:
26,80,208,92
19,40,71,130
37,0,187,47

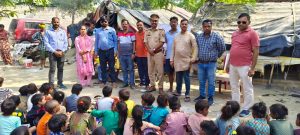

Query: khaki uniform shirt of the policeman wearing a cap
144,28,165,49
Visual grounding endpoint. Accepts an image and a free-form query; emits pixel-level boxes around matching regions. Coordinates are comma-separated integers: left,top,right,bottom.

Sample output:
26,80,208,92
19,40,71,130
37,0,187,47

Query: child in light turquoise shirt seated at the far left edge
0,98,21,135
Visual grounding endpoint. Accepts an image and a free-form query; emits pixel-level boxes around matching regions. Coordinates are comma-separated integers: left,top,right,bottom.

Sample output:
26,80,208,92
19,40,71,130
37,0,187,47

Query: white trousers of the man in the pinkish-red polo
229,65,254,110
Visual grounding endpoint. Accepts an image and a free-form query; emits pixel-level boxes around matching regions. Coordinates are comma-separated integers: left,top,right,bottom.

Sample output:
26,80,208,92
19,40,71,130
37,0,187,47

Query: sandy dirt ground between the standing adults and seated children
0,59,300,126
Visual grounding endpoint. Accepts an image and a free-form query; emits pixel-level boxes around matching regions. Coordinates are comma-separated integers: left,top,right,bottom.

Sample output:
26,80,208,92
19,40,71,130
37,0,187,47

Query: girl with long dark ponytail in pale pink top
123,105,160,135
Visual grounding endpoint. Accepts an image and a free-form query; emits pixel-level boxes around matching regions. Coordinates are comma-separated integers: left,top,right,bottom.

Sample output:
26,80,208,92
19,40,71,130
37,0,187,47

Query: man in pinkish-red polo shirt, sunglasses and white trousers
229,13,259,117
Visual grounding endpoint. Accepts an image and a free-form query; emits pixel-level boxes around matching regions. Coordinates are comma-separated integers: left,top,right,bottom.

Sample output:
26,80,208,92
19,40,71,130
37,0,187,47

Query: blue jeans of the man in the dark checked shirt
198,62,216,98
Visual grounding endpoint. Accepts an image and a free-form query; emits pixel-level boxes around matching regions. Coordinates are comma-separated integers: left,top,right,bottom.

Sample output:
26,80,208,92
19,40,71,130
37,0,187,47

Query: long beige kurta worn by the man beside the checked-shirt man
170,32,198,72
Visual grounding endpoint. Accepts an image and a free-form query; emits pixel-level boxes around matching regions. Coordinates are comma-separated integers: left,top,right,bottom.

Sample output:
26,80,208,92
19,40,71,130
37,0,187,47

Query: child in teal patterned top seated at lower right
246,102,270,135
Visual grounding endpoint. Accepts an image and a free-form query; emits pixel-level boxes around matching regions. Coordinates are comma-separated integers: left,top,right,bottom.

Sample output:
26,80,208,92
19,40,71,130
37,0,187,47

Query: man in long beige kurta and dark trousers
170,19,198,102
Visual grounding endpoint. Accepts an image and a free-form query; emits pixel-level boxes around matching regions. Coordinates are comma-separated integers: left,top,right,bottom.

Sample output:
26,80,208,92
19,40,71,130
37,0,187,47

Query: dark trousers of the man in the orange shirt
135,57,150,86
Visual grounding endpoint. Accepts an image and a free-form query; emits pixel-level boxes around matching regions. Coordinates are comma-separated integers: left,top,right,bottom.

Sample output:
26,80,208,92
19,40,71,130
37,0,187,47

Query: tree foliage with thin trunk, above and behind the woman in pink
52,0,94,24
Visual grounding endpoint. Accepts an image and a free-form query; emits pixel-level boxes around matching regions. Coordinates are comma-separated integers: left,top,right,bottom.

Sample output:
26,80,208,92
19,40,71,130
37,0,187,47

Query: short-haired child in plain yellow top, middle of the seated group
119,89,135,117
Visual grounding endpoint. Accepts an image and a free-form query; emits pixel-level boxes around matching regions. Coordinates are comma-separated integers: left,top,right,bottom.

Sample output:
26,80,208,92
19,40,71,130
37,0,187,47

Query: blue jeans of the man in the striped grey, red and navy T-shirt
119,55,134,86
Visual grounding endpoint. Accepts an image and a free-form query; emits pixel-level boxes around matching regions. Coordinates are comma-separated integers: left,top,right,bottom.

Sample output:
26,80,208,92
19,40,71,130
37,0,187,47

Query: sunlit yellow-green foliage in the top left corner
0,0,50,19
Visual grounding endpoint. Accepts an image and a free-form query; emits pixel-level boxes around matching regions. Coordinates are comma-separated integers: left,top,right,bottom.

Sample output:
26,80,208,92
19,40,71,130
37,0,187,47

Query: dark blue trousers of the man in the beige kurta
176,70,191,96
